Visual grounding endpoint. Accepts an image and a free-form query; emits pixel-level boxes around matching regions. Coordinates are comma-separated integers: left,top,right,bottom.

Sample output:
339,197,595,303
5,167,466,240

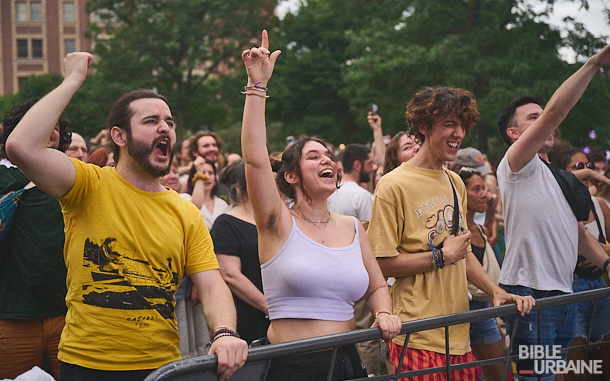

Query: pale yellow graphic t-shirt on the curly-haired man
368,163,470,355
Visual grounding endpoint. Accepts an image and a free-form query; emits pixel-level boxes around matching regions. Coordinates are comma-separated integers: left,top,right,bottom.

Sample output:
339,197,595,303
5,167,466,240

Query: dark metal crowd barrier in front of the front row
145,287,610,381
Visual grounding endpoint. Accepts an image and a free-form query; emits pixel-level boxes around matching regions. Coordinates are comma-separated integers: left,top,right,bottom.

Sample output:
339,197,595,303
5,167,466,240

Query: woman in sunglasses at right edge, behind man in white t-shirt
553,148,610,380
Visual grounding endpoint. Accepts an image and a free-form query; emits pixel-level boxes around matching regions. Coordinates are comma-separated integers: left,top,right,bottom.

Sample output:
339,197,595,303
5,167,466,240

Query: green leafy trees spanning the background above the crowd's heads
0,0,610,160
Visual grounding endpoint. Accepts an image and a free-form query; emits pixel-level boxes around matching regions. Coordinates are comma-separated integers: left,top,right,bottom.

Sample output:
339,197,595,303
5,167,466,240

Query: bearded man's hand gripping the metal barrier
208,336,248,381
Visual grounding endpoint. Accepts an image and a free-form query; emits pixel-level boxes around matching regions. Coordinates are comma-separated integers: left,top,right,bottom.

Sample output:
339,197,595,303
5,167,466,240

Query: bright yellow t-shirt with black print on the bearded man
58,159,218,370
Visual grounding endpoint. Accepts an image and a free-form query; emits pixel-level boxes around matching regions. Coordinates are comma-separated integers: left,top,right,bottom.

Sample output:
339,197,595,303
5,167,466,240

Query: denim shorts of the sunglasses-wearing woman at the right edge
572,275,610,343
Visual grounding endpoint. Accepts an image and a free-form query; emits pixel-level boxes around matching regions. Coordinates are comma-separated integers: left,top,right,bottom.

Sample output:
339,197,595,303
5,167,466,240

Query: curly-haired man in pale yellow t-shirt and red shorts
368,87,533,380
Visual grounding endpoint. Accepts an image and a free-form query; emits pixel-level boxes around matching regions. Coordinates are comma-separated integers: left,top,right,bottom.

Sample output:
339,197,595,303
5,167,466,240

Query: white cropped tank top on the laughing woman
261,217,369,321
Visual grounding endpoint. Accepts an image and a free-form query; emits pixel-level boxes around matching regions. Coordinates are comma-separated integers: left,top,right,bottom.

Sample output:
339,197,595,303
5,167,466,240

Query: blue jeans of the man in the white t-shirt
500,284,576,381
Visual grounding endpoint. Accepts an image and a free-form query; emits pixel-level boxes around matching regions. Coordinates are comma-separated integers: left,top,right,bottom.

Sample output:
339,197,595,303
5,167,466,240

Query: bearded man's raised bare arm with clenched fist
6,52,93,197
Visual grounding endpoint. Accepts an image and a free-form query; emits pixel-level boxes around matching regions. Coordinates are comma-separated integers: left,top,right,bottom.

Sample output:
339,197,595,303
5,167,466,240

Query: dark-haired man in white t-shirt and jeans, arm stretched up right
497,46,610,380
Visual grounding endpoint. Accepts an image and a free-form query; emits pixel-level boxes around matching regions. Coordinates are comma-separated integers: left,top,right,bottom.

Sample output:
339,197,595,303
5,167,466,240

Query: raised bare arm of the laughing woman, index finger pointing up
241,31,290,255
